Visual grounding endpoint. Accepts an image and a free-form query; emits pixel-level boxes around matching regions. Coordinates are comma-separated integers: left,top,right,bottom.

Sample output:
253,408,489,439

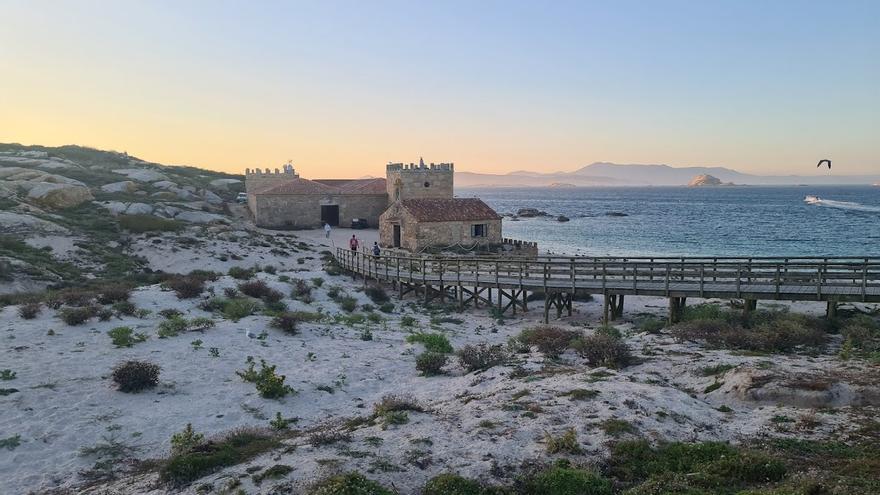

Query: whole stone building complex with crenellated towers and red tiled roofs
245,160,502,252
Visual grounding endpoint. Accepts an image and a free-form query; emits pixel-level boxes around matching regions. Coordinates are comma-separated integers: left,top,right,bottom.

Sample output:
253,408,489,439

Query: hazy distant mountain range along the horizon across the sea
455,162,880,187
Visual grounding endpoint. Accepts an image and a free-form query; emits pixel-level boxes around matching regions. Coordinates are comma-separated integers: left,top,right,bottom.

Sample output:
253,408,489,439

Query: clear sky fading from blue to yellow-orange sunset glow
0,0,880,178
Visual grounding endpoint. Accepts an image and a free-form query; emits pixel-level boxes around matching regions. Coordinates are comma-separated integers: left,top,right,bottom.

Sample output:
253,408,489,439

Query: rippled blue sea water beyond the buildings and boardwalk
456,186,880,256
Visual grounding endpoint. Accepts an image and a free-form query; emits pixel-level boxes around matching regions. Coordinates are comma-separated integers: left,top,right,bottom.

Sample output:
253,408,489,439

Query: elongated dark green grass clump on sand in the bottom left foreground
159,428,280,485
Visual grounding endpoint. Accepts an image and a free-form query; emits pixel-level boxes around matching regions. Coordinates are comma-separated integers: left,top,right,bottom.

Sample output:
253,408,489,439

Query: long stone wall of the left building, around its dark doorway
248,194,388,229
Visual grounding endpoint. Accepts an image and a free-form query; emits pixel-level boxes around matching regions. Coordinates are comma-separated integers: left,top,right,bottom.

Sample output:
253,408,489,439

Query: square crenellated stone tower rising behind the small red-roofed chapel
385,158,453,202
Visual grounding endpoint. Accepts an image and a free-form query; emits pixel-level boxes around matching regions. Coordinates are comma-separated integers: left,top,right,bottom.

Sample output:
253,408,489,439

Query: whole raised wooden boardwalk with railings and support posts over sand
336,248,880,321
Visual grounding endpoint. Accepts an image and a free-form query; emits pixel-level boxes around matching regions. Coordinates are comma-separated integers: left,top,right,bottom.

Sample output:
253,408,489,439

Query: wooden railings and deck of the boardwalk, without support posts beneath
336,249,880,301
